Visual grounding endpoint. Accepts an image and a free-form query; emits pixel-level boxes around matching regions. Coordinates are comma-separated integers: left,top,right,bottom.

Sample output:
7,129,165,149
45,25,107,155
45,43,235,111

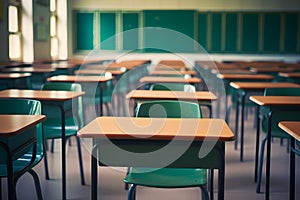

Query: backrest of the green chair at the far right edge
262,88,300,137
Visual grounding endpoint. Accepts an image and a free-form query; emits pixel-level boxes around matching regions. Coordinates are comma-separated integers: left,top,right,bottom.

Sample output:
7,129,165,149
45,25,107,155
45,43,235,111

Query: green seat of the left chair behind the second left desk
43,118,79,139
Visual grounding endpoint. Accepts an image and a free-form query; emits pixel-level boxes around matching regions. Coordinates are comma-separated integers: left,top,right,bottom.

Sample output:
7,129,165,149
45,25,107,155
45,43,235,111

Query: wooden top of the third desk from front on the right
230,82,300,90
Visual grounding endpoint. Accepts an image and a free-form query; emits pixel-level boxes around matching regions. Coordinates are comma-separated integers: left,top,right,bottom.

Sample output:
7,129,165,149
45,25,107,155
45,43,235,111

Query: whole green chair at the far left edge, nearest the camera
0,99,44,199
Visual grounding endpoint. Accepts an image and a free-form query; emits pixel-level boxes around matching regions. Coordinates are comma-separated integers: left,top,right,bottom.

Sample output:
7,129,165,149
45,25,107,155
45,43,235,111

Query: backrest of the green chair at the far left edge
0,99,44,162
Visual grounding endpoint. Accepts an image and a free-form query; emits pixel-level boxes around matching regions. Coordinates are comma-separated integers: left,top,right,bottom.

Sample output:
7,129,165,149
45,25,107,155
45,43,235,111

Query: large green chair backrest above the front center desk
136,100,202,118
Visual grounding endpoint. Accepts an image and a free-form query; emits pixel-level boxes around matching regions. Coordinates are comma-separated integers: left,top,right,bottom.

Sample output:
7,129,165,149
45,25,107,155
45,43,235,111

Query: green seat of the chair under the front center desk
124,167,207,188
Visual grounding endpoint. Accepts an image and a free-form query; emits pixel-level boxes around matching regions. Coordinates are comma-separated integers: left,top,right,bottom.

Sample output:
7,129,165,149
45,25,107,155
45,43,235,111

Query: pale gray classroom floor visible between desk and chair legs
2,105,300,200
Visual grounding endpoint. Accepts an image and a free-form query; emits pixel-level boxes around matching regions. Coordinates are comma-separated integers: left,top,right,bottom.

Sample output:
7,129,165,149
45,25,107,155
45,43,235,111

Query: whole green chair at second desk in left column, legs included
42,82,85,185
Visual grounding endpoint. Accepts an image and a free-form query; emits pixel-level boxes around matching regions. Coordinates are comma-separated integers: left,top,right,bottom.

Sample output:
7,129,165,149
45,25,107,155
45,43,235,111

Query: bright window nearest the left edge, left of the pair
8,1,21,60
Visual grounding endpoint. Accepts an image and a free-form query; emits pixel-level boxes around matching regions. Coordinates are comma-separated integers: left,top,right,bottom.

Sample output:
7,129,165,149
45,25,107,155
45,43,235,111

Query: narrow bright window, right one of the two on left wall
50,0,58,58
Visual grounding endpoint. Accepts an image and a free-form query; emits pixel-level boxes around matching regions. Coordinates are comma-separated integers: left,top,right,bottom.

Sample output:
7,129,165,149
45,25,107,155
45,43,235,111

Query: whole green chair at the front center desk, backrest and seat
124,101,209,199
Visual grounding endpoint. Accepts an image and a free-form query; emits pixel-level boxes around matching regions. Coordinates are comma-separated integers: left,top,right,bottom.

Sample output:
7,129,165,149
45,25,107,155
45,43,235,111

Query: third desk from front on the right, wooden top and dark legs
230,82,300,162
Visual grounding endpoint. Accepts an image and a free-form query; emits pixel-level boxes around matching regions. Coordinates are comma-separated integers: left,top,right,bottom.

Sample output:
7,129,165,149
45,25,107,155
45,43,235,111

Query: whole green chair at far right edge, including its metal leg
256,88,300,193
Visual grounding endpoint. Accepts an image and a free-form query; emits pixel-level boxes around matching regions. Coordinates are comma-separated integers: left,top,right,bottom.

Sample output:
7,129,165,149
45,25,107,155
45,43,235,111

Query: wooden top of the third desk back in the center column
140,76,201,83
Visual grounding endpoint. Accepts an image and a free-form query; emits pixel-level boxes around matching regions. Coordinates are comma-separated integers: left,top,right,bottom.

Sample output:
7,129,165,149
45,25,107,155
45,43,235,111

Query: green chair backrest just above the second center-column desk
150,83,196,92
